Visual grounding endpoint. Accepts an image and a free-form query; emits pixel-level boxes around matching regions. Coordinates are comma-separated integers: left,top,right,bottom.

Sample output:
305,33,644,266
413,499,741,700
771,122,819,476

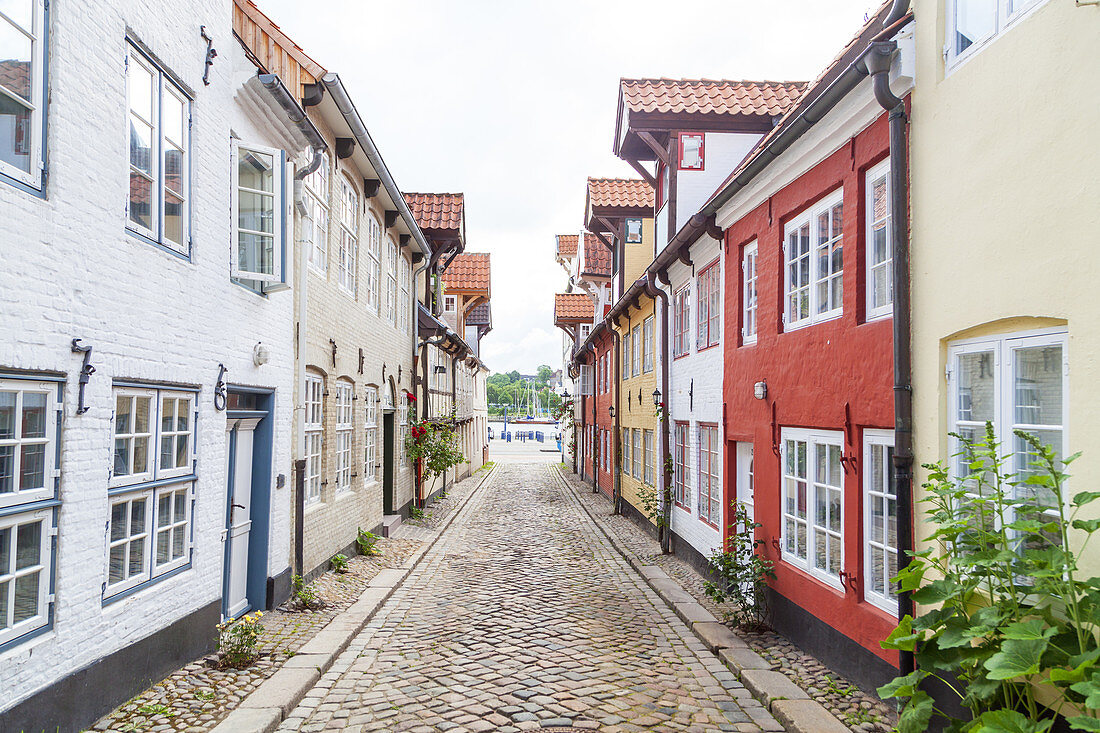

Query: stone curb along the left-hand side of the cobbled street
213,466,497,733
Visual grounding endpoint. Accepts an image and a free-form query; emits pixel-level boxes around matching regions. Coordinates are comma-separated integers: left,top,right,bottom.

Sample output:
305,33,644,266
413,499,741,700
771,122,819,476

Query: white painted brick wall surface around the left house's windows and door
0,0,294,708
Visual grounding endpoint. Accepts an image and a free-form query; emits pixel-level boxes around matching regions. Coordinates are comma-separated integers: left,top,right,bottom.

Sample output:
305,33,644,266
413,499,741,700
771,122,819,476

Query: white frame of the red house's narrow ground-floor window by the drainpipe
862,429,898,614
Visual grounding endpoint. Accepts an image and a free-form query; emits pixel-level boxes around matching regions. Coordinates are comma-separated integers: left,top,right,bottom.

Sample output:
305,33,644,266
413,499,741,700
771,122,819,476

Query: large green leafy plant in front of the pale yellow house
879,424,1100,733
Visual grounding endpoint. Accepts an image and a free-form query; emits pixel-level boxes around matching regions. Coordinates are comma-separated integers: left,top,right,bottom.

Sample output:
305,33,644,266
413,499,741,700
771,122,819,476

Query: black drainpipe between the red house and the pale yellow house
864,35,915,675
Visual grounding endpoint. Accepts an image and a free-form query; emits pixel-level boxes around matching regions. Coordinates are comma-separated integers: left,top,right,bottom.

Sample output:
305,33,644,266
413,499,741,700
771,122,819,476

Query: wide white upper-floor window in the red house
783,189,844,329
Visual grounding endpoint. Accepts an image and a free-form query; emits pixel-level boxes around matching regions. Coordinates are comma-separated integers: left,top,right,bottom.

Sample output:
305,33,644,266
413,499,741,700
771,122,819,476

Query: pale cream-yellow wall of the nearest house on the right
911,0,1100,561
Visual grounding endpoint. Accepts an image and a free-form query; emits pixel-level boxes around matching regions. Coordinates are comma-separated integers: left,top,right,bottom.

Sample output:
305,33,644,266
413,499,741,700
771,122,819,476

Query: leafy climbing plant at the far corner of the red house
703,502,776,631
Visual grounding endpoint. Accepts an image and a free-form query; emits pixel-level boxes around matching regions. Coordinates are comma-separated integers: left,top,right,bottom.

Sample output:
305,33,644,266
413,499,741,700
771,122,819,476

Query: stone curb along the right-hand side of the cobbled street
552,466,851,733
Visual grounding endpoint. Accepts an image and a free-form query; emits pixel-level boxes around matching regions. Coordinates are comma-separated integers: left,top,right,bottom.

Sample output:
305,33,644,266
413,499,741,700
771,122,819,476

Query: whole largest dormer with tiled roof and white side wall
614,79,806,245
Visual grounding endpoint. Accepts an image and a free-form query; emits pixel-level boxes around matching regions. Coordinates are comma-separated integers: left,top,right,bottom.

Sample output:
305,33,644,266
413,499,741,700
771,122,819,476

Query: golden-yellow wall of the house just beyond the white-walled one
616,294,662,513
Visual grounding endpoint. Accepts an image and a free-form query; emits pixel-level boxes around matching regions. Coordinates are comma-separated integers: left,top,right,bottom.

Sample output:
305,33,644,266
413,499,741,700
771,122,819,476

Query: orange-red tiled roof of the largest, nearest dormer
619,79,806,116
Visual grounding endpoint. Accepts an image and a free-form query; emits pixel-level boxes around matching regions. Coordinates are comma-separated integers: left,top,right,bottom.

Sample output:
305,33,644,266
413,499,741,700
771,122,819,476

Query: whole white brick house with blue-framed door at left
0,0,310,731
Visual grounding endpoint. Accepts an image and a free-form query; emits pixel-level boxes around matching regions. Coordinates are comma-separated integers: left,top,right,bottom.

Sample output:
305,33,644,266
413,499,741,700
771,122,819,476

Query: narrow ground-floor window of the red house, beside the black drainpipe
864,430,898,613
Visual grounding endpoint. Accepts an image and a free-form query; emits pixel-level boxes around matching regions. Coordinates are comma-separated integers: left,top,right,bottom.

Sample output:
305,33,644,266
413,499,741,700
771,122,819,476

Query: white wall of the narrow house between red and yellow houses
669,236,728,556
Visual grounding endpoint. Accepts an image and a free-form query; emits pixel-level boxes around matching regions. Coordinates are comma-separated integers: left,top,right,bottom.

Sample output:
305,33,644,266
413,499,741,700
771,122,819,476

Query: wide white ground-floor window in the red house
782,428,844,588
